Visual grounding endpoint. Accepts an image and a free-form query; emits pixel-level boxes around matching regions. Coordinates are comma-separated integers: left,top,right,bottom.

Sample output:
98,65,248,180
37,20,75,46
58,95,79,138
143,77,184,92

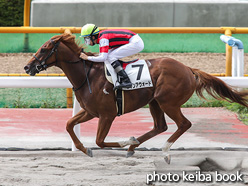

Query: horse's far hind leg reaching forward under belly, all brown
127,100,167,157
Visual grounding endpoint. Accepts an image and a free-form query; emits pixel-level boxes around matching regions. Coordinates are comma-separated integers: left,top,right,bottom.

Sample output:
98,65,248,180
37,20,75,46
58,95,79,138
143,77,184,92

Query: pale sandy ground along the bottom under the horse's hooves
0,150,248,186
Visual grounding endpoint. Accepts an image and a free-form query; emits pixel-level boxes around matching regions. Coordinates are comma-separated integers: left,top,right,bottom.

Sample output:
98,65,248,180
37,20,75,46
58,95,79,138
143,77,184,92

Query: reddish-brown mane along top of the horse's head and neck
52,32,94,56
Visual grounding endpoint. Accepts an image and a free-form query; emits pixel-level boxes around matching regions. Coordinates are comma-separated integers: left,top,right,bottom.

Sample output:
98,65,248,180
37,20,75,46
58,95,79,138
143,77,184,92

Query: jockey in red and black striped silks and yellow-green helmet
80,24,144,90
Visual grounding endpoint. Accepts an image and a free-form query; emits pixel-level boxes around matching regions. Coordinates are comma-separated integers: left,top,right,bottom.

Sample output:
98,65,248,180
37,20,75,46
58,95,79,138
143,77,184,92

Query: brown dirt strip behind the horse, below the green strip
0,53,248,73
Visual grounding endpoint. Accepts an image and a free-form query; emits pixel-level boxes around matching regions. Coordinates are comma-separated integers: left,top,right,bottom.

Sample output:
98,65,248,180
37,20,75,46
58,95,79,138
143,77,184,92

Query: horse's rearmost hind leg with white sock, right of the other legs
161,105,192,163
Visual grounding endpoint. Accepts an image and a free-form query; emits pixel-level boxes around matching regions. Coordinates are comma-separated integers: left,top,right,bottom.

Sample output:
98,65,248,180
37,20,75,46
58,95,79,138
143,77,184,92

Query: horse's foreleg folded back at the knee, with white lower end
96,116,139,148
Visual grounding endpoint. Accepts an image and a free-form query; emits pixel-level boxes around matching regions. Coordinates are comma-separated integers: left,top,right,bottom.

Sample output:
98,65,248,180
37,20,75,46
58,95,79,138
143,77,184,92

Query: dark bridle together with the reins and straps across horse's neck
33,39,93,93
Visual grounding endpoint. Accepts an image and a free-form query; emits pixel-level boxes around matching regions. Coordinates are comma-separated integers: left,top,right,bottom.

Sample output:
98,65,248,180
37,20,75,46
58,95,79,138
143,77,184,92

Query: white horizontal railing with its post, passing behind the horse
0,77,248,151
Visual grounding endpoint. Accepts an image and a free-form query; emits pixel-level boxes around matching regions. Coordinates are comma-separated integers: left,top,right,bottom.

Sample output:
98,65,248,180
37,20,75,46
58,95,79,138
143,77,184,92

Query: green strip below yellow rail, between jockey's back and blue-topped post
139,34,225,53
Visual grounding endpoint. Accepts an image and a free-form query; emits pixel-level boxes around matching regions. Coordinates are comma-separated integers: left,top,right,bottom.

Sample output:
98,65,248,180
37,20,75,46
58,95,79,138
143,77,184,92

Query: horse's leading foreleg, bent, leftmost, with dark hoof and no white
66,109,94,157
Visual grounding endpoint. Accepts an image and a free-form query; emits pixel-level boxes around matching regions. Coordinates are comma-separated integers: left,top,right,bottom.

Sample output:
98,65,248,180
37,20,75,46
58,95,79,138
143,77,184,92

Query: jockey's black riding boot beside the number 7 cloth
111,60,132,90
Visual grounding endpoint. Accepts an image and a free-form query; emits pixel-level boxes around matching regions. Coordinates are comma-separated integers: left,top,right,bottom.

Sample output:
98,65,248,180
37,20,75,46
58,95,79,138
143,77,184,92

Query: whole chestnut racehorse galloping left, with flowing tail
24,32,248,163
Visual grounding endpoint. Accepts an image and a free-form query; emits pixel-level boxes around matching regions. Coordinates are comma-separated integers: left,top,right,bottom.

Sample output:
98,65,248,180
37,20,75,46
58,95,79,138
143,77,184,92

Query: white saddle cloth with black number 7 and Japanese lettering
105,60,153,90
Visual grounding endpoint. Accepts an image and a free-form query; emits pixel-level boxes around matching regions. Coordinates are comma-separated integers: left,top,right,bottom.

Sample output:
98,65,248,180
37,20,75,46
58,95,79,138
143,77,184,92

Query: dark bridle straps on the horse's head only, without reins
33,39,60,72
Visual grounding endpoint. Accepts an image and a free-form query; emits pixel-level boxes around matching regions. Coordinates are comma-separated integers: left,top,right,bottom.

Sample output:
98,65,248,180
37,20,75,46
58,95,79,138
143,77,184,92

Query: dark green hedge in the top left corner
0,0,24,26
